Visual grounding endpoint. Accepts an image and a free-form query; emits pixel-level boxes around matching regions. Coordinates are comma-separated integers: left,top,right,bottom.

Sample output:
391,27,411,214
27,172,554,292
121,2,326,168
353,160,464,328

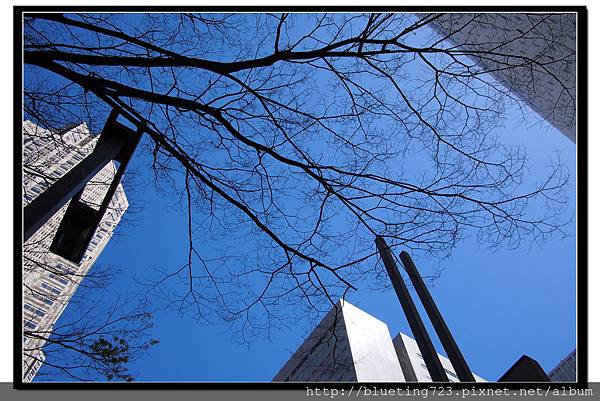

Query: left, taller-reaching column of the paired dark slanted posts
375,236,448,382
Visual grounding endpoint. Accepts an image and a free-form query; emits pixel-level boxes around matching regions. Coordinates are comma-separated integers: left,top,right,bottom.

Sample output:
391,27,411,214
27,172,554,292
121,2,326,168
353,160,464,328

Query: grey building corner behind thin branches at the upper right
430,13,577,142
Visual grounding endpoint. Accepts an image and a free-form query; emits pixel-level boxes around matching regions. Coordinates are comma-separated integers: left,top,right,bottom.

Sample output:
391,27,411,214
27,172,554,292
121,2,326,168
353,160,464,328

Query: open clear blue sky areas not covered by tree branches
31,13,576,381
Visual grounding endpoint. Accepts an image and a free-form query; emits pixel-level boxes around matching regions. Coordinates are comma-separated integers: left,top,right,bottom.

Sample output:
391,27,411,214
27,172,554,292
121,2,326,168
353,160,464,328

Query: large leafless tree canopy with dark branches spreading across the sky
23,13,569,339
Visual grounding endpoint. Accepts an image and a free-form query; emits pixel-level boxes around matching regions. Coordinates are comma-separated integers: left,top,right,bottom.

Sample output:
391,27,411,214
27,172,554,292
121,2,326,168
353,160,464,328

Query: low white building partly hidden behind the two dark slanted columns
393,333,486,382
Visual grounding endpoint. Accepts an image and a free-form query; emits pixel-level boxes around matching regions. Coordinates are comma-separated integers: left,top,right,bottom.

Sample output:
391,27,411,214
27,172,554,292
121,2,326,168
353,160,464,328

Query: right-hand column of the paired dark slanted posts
400,251,475,382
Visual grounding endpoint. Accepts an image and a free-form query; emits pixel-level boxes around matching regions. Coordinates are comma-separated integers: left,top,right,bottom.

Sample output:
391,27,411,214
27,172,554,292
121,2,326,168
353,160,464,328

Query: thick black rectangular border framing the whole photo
13,5,589,395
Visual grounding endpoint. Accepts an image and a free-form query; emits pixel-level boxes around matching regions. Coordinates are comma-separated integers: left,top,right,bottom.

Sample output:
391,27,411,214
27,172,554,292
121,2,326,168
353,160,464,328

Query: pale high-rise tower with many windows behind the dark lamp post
22,121,129,381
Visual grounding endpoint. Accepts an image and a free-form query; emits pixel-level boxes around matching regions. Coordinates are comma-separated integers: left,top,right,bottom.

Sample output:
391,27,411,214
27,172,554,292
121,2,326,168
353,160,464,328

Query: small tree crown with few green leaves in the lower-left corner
23,287,158,381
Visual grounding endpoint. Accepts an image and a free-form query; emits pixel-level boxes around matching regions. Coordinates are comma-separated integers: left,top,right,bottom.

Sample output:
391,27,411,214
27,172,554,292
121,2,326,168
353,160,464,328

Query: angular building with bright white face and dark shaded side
273,300,404,382
